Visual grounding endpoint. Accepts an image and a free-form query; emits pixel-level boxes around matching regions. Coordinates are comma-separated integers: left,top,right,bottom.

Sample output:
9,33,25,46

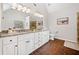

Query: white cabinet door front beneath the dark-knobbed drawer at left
3,44,17,55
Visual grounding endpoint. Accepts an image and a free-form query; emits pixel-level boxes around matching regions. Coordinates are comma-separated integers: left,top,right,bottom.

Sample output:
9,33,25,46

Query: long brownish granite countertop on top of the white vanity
0,30,46,38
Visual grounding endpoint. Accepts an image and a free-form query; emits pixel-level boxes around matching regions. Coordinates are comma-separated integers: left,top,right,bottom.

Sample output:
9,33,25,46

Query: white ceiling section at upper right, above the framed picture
46,3,79,13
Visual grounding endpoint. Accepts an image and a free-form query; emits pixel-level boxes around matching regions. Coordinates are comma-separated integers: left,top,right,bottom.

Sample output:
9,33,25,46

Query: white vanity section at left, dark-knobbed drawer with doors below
2,36,17,55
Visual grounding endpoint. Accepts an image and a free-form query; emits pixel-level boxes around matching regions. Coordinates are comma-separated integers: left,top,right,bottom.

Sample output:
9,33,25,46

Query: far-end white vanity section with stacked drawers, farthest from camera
34,31,49,49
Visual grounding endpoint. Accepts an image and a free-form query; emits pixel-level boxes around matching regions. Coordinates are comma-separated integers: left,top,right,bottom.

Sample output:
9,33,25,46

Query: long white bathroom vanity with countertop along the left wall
0,30,49,55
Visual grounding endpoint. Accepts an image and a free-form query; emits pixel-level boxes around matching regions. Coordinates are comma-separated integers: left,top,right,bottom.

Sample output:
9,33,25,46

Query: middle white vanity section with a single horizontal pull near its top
18,33,34,55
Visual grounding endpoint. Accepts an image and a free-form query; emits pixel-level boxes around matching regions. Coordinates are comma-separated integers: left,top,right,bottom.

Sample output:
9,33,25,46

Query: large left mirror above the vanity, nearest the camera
1,3,29,30
